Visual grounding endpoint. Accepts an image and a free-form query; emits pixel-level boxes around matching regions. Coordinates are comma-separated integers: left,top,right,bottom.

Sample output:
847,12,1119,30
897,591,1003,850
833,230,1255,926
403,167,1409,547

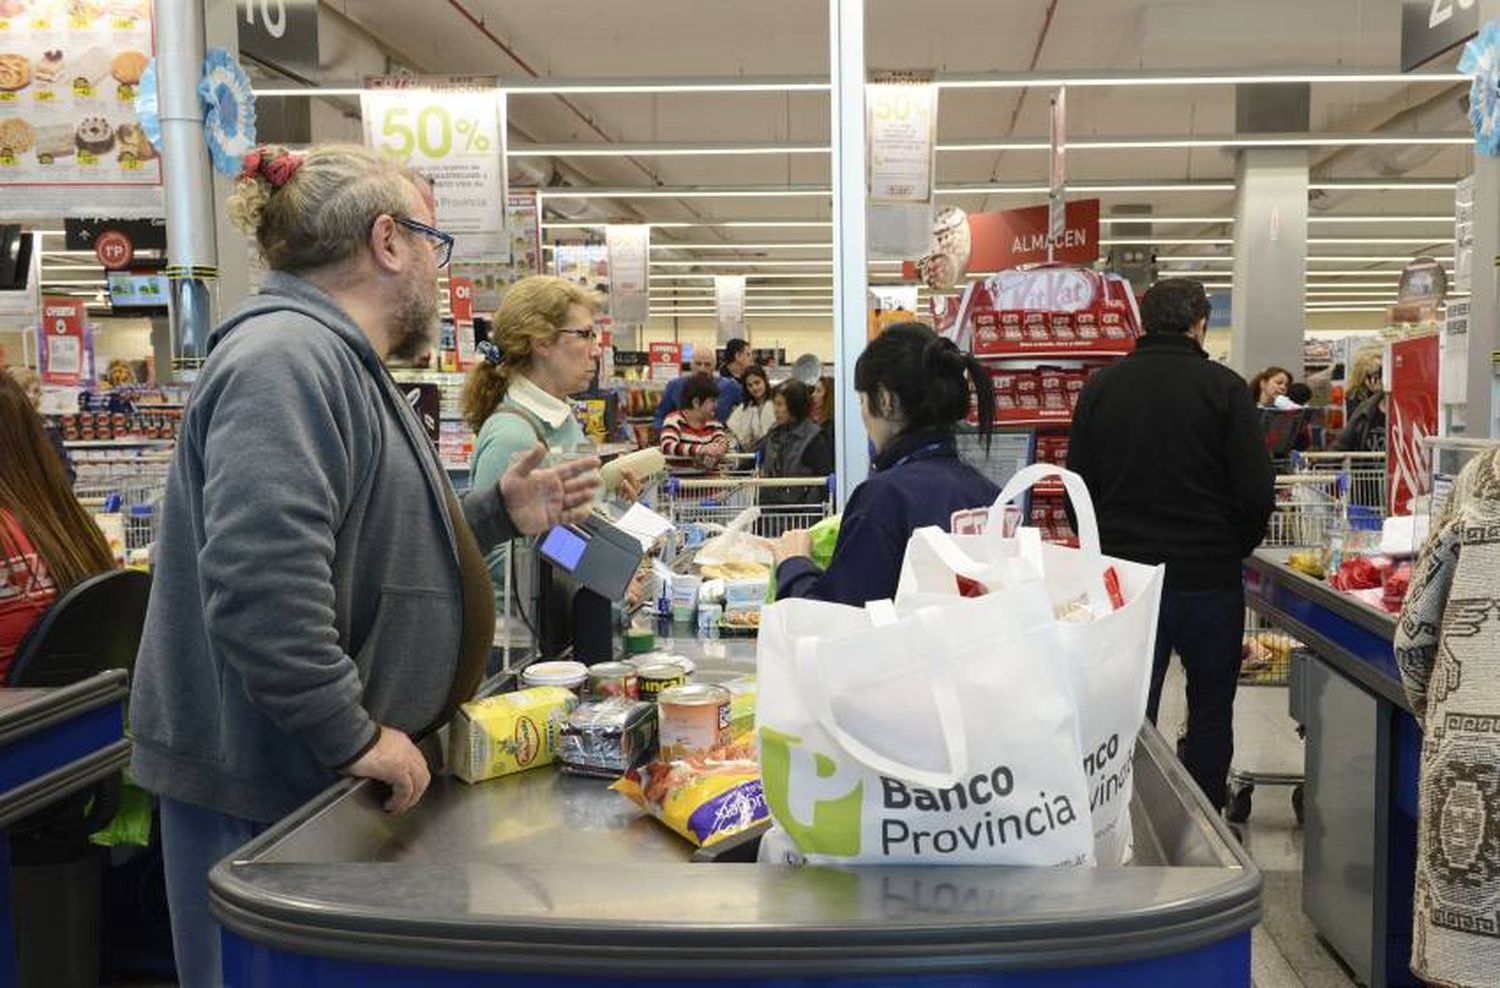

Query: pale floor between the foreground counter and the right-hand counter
1160,664,1358,988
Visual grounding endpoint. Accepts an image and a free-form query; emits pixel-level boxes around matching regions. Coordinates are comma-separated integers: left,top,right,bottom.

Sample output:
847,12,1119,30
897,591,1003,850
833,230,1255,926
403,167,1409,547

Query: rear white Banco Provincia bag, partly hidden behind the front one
896,463,1166,865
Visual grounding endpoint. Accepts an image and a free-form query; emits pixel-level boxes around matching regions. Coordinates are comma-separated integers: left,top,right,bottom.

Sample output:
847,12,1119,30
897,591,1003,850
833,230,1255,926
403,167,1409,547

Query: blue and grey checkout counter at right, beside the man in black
1245,549,1422,987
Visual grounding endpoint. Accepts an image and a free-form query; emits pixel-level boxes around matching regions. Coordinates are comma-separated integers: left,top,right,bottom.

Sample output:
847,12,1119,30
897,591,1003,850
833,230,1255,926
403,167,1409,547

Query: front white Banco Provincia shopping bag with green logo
756,586,1094,865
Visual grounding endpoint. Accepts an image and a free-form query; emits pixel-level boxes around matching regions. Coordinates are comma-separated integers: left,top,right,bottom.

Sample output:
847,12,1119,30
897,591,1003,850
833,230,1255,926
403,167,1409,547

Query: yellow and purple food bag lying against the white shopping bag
611,759,767,847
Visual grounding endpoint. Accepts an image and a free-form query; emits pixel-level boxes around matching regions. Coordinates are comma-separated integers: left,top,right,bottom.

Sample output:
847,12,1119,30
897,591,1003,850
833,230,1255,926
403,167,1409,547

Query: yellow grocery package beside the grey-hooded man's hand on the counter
449,687,578,783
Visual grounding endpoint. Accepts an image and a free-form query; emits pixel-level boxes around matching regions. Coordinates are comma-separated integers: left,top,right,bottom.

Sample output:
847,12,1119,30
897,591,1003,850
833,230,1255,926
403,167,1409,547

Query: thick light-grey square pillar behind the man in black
1229,147,1308,378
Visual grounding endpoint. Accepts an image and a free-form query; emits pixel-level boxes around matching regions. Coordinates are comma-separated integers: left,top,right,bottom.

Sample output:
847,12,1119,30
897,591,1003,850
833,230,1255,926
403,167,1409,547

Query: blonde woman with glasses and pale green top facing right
462,274,641,501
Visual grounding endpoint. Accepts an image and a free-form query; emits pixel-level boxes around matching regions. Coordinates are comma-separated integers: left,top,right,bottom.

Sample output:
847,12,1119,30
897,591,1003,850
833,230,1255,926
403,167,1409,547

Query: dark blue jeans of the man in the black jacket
1146,588,1245,810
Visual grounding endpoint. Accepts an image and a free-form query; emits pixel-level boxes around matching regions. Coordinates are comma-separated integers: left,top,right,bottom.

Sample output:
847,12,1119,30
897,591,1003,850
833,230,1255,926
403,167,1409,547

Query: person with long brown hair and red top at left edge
0,375,114,684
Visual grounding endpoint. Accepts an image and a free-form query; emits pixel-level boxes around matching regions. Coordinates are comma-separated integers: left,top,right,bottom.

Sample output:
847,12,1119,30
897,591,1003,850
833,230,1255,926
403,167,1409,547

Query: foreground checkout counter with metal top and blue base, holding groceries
210,627,1260,988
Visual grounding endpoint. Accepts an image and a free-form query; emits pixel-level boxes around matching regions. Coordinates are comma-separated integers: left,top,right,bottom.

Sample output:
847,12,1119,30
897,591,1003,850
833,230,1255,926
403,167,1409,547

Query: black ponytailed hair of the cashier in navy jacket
854,322,995,442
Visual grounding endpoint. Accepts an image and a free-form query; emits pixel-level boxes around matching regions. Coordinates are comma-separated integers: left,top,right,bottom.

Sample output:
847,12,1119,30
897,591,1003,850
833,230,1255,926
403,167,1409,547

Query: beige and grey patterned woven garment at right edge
1395,447,1500,988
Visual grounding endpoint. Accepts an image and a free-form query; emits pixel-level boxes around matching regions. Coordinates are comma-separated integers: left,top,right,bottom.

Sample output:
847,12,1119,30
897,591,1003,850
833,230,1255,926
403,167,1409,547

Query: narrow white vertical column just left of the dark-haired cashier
828,0,870,511
